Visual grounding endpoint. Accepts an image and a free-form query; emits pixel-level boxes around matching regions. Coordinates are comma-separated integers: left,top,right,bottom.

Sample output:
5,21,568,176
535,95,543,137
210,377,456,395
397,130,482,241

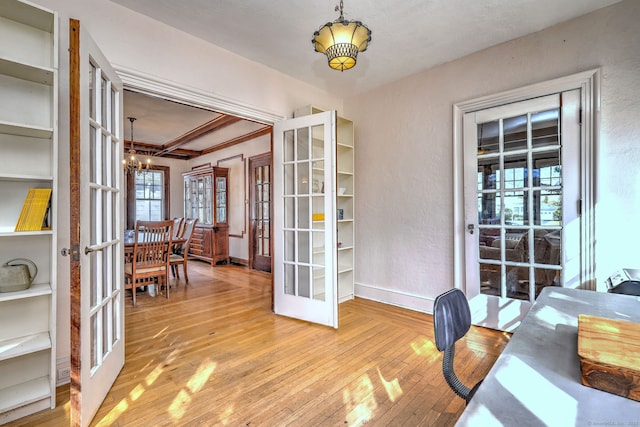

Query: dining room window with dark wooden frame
126,166,170,230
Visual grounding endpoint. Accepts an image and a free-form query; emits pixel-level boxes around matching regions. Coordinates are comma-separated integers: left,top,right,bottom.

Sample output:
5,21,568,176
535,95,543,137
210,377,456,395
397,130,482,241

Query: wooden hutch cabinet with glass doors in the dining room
182,165,229,265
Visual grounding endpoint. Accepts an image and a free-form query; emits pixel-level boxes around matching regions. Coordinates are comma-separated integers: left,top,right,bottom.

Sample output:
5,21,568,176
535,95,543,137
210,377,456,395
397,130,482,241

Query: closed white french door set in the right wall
463,90,580,331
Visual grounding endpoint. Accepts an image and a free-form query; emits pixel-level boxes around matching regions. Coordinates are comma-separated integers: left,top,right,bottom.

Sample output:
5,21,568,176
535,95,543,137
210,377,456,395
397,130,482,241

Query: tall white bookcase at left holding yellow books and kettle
0,0,58,424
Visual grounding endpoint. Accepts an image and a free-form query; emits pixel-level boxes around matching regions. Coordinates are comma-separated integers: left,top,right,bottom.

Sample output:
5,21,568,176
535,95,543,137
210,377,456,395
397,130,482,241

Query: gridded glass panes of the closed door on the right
477,107,562,301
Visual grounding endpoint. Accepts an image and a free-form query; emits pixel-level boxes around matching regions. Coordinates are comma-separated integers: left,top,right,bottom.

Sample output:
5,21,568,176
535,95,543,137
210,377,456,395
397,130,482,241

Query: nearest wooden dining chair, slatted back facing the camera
124,220,173,306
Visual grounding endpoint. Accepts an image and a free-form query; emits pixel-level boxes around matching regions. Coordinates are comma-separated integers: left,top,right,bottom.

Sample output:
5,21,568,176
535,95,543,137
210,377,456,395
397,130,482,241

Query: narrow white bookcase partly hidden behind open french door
294,106,355,302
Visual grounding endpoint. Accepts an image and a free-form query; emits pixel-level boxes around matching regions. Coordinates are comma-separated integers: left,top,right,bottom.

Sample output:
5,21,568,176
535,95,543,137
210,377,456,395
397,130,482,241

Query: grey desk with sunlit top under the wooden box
456,287,640,427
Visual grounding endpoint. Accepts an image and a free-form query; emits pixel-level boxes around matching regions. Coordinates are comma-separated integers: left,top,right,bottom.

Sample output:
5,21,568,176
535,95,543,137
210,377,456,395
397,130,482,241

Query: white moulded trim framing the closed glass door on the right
452,69,600,292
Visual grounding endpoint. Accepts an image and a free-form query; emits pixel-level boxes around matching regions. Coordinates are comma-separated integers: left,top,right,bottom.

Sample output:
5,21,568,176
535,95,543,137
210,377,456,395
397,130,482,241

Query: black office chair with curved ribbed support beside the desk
433,289,482,404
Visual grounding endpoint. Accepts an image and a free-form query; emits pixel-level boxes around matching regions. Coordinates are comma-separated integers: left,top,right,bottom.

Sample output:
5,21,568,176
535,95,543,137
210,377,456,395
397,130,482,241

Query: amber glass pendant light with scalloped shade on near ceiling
311,0,371,71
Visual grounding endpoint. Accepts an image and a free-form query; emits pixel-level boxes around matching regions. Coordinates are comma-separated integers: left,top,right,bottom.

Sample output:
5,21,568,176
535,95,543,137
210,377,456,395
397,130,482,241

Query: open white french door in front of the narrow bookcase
273,111,338,328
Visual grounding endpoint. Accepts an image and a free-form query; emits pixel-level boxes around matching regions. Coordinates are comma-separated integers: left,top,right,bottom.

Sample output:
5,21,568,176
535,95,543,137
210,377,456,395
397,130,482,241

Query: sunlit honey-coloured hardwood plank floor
9,262,509,427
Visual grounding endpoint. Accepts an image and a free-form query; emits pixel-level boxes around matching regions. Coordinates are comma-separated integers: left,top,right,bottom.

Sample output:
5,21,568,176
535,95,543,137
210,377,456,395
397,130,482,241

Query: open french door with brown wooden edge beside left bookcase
69,19,124,426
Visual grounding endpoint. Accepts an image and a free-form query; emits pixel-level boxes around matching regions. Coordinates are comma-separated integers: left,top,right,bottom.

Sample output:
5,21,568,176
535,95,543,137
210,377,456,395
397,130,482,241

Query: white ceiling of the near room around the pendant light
112,0,620,97
